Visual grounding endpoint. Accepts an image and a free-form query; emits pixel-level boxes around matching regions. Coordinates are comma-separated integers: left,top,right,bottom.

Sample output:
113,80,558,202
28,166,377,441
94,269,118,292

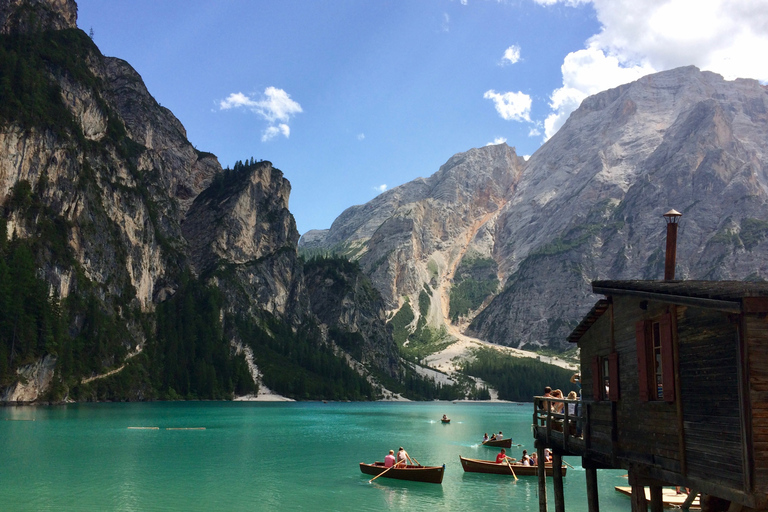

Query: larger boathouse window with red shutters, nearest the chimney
635,313,675,402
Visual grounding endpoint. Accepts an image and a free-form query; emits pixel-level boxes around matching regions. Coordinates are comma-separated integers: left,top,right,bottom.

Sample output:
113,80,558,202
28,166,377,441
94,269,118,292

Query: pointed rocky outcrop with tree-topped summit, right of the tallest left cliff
182,162,306,318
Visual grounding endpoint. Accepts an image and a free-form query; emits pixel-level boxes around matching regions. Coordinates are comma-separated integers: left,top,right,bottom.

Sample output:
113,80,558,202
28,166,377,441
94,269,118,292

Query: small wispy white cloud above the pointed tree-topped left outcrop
219,87,303,141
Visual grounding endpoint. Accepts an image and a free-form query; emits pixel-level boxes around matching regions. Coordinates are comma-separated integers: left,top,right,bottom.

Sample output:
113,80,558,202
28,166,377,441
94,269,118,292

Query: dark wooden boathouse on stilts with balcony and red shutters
533,210,768,512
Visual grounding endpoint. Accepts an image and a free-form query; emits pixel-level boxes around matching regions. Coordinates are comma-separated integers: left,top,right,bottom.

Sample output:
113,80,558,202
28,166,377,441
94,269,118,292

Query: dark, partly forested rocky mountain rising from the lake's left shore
0,0,400,401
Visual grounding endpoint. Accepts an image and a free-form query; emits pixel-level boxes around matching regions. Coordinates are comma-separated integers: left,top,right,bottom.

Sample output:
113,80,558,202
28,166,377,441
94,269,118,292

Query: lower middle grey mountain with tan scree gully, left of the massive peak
301,144,523,308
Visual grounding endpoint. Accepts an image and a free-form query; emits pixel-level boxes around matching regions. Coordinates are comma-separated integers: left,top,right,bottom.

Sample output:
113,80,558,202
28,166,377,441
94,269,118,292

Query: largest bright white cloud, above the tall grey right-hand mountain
535,0,768,138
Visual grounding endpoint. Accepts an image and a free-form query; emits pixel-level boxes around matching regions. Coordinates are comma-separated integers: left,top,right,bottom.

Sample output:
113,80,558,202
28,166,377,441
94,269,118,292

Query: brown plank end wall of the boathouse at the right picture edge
744,315,768,492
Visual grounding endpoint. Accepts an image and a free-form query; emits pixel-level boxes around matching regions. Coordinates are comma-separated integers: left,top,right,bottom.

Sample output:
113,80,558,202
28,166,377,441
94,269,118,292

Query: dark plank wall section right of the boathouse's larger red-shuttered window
677,307,744,490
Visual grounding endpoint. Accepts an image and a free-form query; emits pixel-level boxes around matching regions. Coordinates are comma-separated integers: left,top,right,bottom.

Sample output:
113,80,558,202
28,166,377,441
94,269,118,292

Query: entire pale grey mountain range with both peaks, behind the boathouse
300,67,768,348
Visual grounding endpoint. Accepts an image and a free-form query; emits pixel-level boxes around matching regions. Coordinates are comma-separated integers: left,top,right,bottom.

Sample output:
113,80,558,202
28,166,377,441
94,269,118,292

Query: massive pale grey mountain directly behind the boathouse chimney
471,67,768,345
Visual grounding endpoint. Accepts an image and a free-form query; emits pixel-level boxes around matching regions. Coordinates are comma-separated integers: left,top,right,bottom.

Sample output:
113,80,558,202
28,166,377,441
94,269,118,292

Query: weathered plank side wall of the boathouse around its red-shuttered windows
579,296,744,489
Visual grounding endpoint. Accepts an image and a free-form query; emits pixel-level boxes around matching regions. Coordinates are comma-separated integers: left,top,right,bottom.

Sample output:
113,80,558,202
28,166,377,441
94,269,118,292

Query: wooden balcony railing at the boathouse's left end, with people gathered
533,396,586,455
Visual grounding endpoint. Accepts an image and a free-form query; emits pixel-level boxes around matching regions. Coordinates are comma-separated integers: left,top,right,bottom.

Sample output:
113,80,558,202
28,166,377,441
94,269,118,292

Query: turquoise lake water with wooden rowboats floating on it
0,402,630,512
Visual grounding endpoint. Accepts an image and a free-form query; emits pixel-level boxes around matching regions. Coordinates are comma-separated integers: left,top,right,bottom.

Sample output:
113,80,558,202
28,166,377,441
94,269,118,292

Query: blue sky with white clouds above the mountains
78,0,768,233
